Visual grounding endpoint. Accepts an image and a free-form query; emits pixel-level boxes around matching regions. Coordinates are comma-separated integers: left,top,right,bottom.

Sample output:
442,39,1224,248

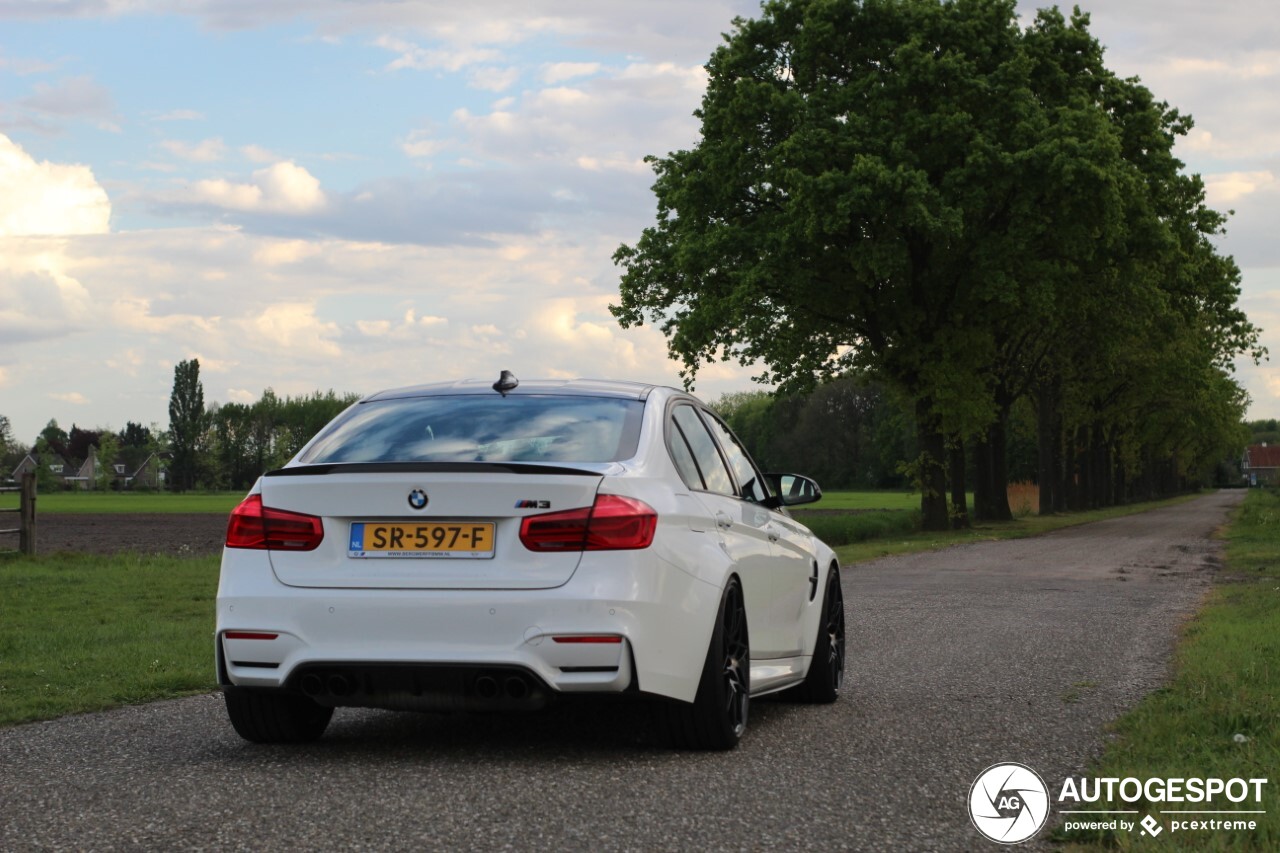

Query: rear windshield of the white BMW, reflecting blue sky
298,394,644,465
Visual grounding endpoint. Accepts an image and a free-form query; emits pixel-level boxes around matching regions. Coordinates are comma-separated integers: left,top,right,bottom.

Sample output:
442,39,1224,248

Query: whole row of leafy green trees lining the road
612,0,1265,529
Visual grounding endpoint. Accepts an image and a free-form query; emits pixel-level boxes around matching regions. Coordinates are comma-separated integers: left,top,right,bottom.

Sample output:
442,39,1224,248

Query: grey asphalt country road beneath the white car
0,493,1243,850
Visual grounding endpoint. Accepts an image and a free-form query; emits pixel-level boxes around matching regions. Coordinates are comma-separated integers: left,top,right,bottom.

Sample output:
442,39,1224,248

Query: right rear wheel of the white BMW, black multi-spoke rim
658,578,751,749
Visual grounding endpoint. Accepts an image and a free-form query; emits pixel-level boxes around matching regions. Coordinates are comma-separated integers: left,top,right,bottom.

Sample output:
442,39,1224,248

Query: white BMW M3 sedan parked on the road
215,371,845,749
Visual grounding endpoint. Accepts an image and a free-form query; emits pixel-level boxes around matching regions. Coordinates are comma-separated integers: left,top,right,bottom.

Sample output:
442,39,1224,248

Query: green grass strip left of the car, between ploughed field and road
0,553,218,725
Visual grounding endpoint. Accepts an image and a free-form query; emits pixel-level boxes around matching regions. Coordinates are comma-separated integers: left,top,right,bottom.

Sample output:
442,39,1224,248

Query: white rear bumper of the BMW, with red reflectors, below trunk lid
216,551,719,710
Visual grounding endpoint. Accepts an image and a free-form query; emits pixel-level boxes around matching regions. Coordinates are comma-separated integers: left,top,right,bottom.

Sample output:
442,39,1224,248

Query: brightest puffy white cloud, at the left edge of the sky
0,134,111,235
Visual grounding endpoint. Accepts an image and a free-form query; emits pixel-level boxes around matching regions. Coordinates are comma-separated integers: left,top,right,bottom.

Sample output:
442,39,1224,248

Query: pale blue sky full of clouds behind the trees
0,0,1280,443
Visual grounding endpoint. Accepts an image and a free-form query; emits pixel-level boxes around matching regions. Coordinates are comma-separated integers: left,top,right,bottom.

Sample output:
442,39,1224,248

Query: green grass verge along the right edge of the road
1055,489,1280,850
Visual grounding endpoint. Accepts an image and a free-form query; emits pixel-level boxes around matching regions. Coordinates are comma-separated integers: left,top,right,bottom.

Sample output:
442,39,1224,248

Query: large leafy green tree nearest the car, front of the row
614,0,1098,529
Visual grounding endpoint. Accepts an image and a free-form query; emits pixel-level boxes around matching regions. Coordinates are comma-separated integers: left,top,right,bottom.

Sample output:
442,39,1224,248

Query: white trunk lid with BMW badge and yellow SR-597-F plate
261,464,603,589
